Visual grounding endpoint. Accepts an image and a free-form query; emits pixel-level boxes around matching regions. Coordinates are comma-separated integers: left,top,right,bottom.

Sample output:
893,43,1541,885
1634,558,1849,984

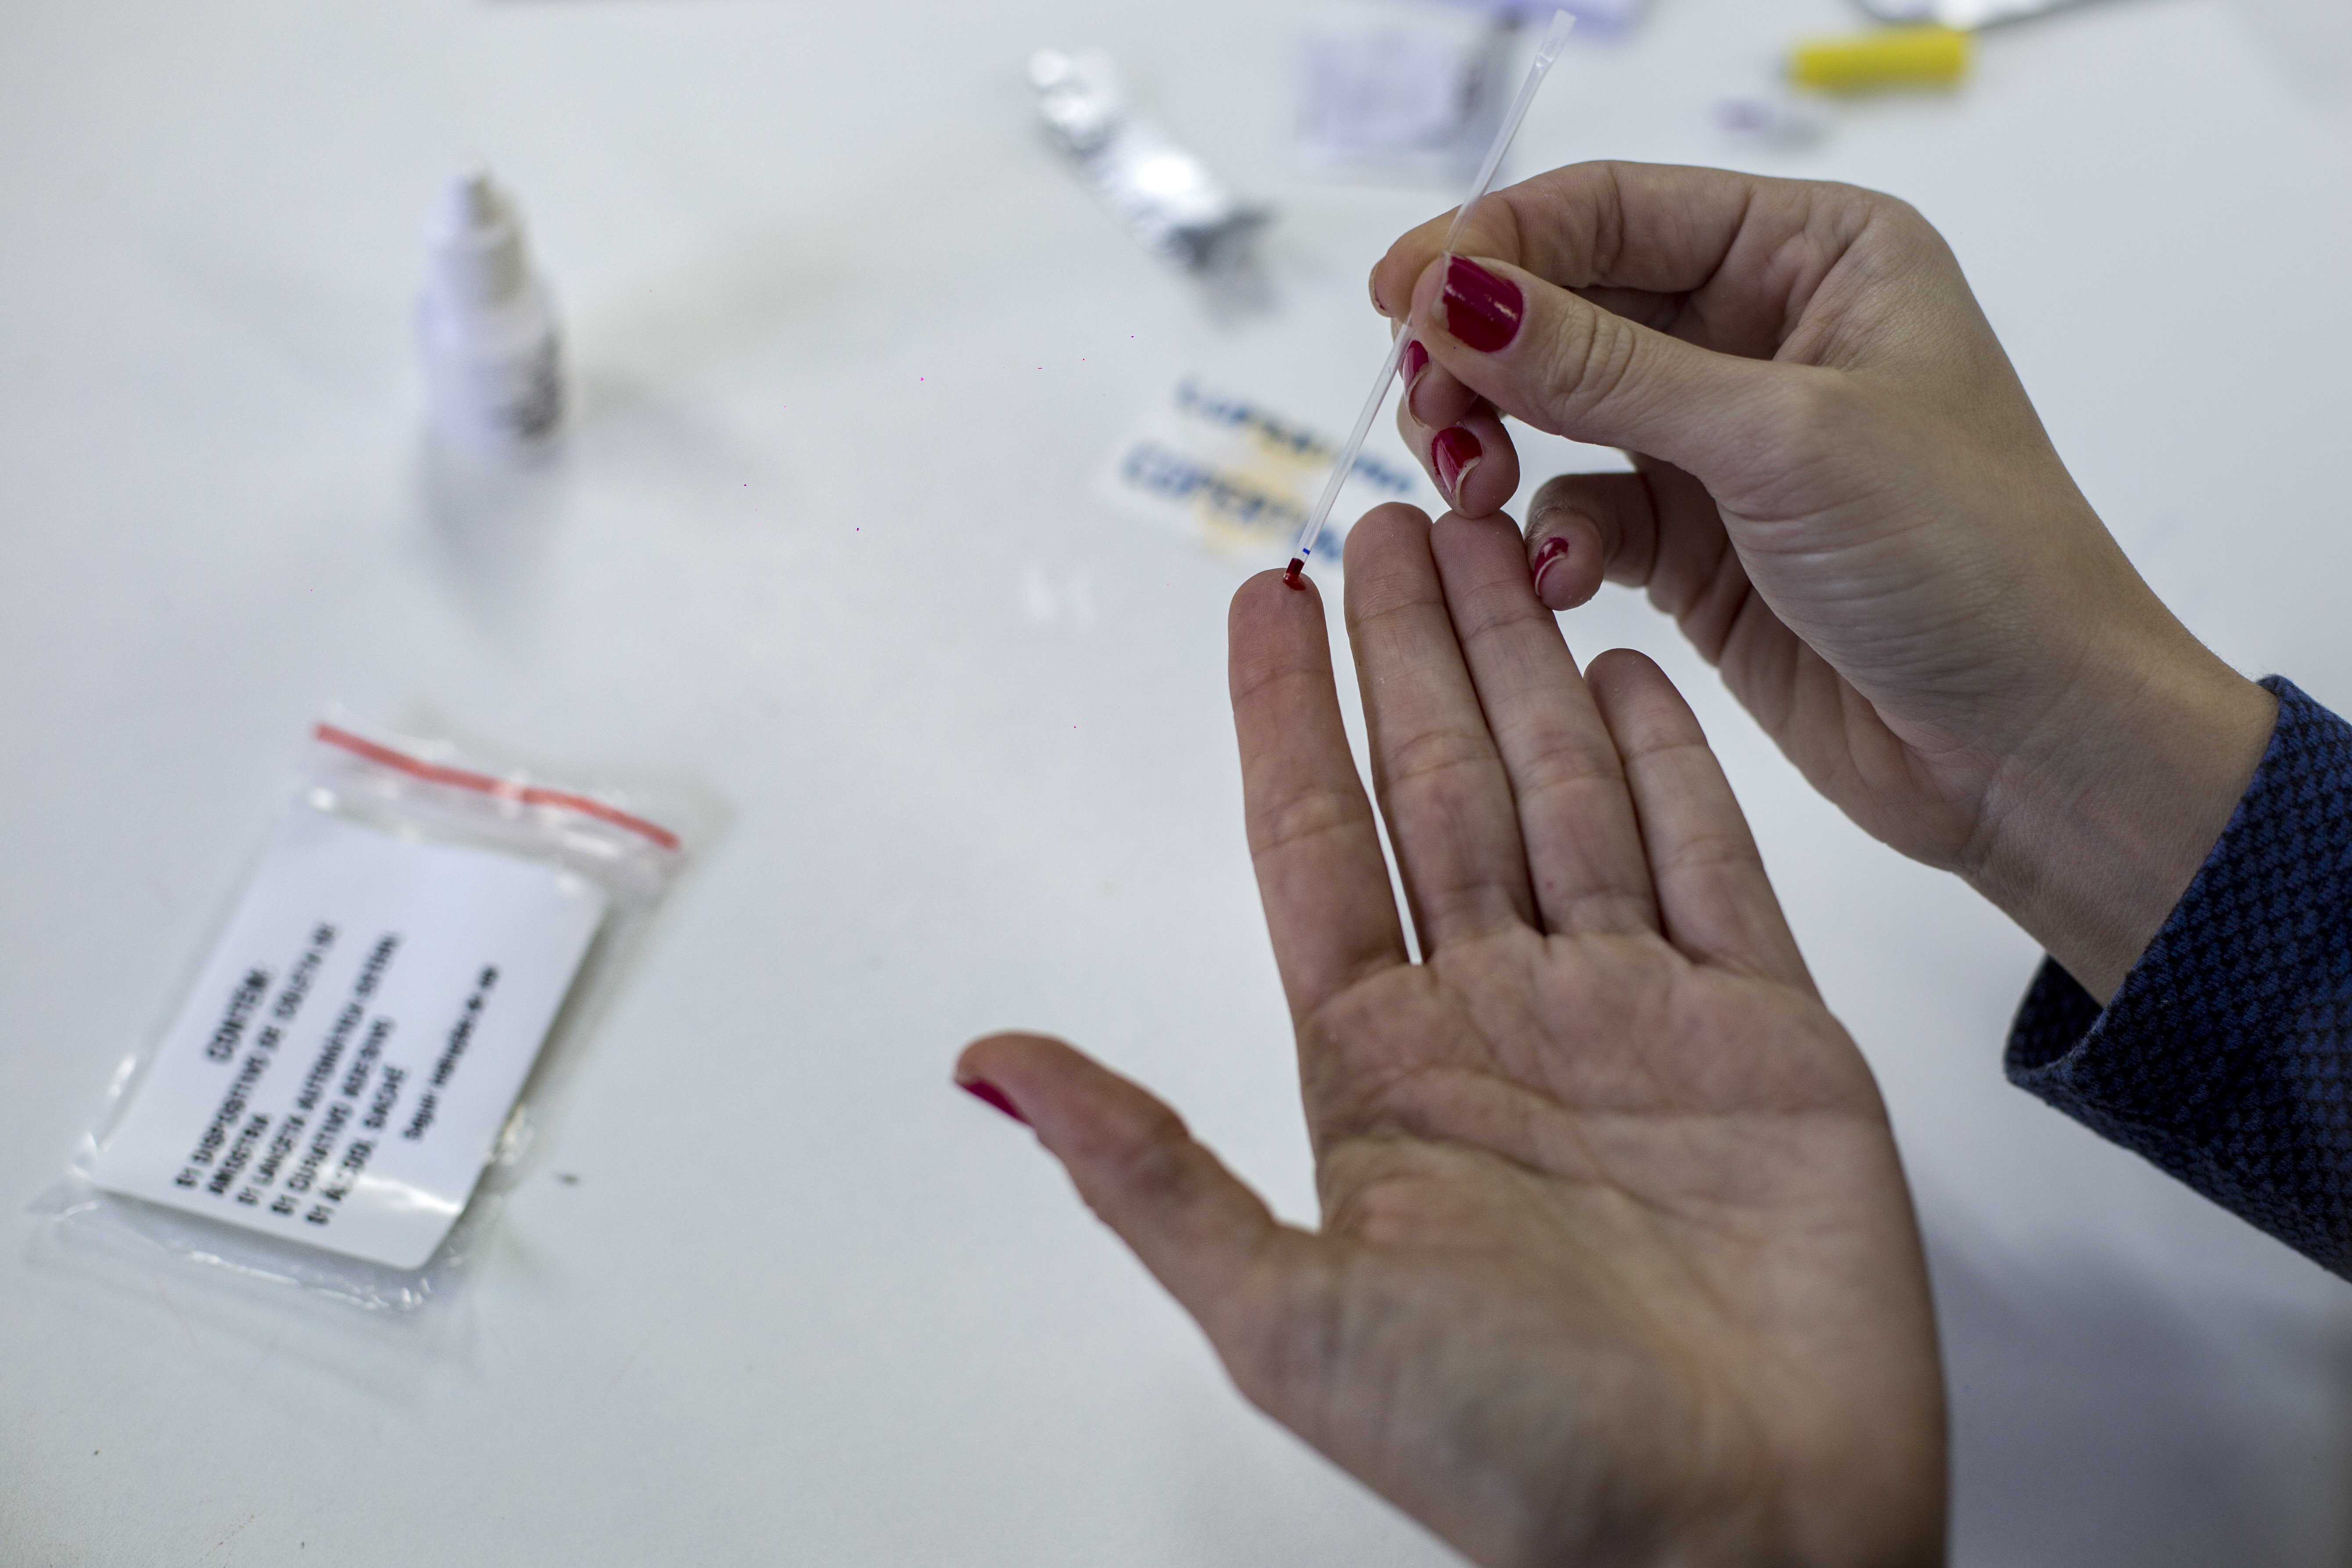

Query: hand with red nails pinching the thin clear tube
1371,165,2274,997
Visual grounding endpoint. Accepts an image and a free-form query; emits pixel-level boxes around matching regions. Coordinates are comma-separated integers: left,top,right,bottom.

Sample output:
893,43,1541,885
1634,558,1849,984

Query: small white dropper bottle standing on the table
416,169,564,454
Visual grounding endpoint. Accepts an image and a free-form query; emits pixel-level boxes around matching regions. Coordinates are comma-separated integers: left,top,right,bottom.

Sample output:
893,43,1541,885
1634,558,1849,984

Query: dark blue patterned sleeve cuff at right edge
2006,675,2352,1279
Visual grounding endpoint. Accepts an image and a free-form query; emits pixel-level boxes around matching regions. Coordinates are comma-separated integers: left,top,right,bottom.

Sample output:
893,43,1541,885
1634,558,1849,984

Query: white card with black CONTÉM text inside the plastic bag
92,809,605,1270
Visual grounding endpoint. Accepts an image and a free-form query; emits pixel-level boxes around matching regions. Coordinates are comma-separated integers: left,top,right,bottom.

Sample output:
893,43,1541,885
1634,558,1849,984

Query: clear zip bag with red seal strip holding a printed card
33,714,685,1310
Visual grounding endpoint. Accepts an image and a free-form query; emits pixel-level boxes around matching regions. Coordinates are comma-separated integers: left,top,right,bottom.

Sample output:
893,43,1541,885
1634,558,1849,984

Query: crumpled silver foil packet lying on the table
1030,49,1273,273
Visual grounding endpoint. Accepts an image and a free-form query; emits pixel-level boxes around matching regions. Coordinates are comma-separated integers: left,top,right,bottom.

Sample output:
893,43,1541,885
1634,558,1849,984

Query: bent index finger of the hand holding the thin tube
1371,162,1900,357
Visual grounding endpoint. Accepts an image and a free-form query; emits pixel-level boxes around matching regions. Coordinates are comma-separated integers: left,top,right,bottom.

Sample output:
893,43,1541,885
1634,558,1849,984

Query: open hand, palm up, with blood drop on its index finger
957,506,1945,1568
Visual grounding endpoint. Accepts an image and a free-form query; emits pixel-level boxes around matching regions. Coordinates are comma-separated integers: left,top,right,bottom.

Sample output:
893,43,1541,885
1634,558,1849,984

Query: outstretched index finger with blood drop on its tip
1226,571,1406,1023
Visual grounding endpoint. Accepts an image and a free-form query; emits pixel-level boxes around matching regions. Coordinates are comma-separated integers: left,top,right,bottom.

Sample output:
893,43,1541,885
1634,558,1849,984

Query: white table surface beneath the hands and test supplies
0,0,2352,1568
